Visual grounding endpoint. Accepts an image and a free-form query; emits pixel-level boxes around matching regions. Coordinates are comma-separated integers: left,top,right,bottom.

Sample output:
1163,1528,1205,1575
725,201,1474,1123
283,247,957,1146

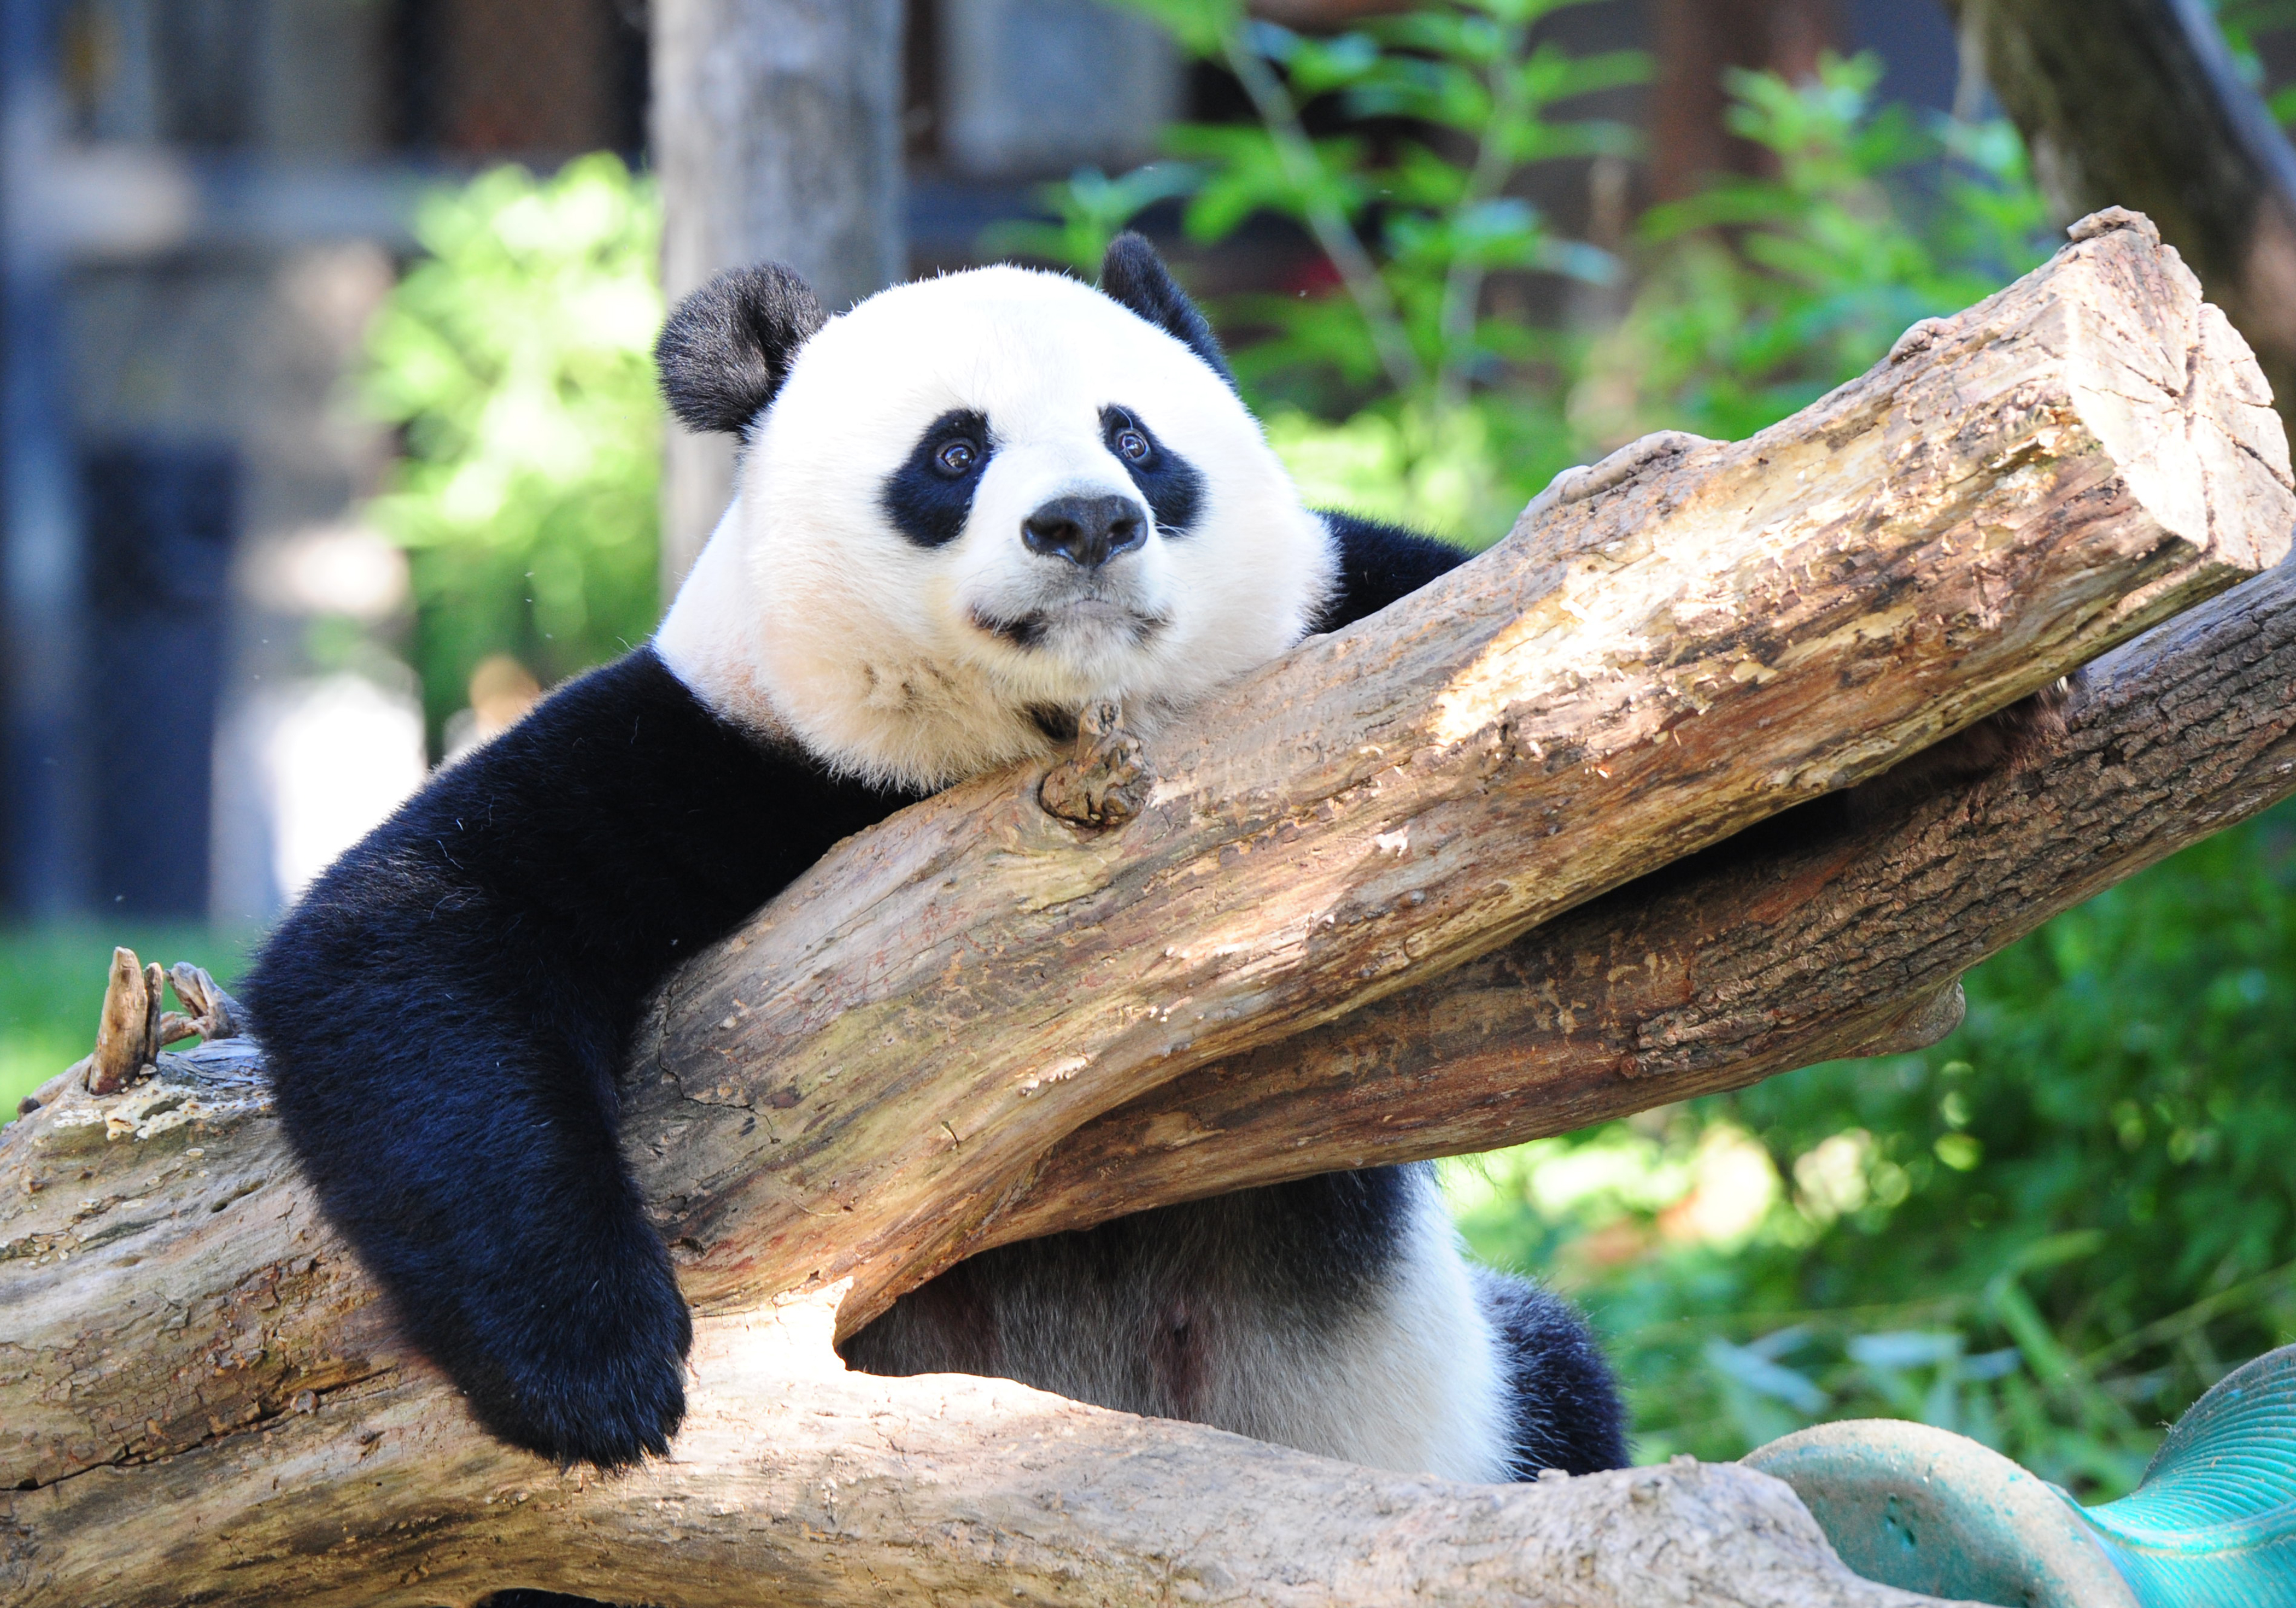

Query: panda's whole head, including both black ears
657,234,1334,788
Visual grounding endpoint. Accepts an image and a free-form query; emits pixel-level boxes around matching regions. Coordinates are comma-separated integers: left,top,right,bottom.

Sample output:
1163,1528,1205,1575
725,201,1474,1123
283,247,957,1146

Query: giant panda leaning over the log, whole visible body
248,237,1623,1482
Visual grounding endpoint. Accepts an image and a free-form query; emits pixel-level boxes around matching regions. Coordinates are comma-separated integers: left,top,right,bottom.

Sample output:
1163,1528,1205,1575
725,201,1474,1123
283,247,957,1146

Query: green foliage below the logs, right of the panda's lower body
1451,806,2296,1495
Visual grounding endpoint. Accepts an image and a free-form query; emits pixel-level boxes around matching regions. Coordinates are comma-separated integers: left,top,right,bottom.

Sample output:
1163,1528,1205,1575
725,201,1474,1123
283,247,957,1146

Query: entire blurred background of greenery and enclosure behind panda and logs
0,0,2296,1495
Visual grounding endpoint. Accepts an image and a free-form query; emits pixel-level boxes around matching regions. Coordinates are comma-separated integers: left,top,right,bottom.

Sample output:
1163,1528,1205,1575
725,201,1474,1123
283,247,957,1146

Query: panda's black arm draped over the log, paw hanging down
248,648,909,1465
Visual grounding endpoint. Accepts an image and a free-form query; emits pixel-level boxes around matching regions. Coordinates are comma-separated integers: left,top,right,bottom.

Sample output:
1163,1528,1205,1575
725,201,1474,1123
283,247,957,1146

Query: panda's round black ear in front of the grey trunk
654,262,829,434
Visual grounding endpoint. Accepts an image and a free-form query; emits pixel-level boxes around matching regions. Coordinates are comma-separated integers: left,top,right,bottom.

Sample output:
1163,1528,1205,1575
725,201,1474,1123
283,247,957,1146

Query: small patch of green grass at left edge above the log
0,924,250,1121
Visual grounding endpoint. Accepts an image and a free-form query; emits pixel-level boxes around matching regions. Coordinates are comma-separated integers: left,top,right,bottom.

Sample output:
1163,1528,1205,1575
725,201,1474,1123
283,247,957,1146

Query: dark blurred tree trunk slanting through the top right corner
1947,0,2296,434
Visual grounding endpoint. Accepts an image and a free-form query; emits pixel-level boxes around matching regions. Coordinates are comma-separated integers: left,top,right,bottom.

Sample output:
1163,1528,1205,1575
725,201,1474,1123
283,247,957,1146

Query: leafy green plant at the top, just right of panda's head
1173,0,1649,407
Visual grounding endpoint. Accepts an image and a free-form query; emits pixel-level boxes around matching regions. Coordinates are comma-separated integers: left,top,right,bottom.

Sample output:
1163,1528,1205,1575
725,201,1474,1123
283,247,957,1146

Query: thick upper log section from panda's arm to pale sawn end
624,220,2296,1328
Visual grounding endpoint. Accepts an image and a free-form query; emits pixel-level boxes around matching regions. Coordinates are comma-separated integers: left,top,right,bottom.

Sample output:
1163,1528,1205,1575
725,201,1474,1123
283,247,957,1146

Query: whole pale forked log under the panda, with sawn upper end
0,217,2296,1606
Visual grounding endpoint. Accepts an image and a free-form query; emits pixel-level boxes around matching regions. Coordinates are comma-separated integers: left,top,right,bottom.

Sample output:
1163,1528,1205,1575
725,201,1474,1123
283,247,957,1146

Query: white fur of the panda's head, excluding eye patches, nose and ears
654,267,1336,788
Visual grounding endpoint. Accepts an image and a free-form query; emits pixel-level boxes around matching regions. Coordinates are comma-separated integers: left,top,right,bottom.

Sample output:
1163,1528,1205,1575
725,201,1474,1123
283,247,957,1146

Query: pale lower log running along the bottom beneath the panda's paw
0,1277,1974,1608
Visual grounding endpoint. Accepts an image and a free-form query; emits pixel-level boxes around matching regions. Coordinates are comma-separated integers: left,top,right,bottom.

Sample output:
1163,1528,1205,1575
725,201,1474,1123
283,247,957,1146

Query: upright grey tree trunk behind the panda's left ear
652,0,905,597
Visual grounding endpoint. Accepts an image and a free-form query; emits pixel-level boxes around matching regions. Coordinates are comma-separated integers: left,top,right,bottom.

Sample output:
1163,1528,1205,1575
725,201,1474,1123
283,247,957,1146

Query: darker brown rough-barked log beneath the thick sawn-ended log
992,533,2296,1249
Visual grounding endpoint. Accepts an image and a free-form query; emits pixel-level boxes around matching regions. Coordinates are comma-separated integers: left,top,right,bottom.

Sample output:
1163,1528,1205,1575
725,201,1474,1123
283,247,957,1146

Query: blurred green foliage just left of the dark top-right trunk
1573,55,2051,441
